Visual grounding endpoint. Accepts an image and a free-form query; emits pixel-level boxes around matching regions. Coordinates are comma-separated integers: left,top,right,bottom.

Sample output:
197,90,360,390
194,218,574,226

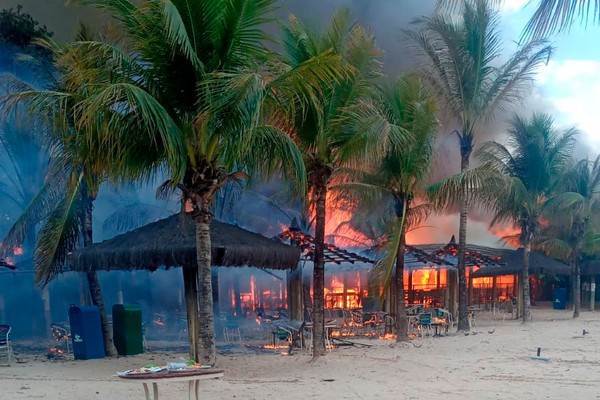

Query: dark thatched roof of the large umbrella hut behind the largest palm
68,214,300,271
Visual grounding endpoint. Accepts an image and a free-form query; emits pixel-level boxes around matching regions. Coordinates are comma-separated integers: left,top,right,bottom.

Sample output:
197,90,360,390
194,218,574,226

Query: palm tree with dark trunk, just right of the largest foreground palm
283,9,403,358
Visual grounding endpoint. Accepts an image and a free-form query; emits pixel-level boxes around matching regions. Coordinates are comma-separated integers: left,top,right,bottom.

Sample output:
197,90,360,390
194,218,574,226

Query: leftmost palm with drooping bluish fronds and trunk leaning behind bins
2,25,116,356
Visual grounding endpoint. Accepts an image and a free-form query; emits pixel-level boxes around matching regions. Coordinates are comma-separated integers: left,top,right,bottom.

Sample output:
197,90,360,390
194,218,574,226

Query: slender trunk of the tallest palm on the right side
458,147,471,331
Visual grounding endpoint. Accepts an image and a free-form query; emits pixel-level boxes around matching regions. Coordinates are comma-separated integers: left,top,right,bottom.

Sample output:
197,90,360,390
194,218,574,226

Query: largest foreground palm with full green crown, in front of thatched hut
7,0,347,364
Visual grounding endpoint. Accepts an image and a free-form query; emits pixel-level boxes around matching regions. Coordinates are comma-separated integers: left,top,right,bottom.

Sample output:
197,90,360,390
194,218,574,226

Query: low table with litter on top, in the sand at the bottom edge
119,369,223,400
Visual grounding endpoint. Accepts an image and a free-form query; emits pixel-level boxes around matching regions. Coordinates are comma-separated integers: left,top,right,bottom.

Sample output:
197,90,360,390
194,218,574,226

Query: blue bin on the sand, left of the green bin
69,305,104,360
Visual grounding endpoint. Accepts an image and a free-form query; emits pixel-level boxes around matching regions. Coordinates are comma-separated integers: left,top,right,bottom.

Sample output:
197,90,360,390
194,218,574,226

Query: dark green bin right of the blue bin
113,304,144,356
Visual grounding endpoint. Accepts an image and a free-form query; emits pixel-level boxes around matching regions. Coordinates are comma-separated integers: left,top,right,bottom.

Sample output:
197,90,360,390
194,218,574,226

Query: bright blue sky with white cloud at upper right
502,0,600,157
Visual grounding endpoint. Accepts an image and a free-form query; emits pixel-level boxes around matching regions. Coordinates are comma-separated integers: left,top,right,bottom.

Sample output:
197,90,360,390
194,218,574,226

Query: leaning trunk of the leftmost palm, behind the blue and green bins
82,197,117,357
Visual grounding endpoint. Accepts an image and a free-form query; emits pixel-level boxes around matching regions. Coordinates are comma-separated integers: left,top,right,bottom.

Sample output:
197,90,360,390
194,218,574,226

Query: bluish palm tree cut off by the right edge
541,156,600,318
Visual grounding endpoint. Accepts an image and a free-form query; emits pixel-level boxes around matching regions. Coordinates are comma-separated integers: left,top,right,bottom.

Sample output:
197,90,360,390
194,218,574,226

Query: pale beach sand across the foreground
0,310,600,400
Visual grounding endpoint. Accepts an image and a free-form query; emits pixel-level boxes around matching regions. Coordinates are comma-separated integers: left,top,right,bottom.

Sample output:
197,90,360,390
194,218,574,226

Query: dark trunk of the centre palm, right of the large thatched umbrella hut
312,179,327,359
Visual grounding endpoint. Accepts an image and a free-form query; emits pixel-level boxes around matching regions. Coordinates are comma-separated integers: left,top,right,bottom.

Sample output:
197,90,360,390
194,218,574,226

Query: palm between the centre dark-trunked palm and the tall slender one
335,75,437,341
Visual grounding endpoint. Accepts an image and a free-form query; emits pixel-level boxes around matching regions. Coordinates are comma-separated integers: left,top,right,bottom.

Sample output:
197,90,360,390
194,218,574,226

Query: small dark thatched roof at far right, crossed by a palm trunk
473,248,570,278
